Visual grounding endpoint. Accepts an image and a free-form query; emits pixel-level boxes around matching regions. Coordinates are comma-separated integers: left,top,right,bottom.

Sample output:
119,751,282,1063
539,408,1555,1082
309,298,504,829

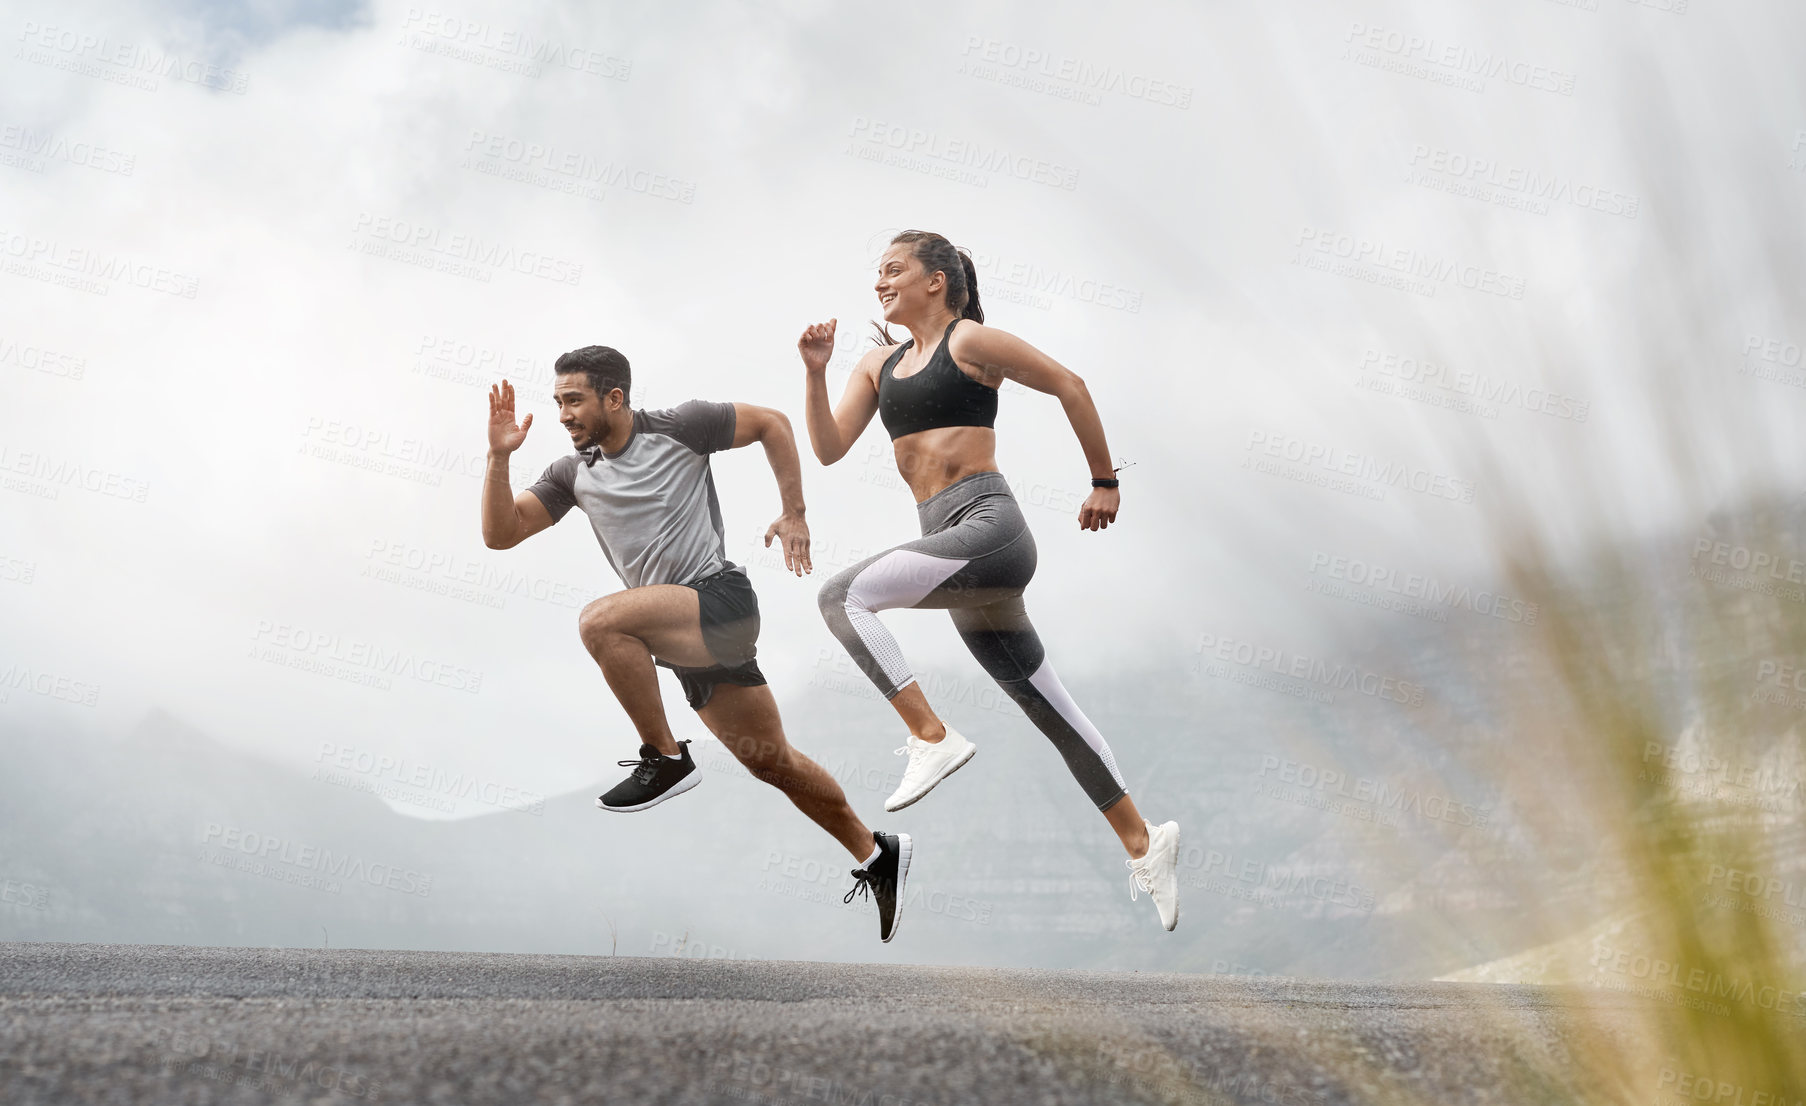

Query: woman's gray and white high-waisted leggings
820,472,1125,810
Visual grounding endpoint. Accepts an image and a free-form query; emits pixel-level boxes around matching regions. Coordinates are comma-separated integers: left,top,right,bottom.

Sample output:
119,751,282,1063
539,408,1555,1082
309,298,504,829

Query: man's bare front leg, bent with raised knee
576,584,715,757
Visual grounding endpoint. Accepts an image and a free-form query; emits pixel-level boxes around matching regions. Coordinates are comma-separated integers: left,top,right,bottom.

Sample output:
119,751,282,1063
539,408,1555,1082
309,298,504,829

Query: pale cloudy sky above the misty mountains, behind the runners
0,0,1806,813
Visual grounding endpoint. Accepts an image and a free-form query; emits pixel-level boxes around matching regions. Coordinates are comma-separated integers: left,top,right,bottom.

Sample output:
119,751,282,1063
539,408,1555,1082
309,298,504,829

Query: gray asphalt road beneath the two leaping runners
0,943,1634,1106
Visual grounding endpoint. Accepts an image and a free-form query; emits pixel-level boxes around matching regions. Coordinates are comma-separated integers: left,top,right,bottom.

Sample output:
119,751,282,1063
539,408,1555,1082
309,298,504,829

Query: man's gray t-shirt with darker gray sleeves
527,399,737,587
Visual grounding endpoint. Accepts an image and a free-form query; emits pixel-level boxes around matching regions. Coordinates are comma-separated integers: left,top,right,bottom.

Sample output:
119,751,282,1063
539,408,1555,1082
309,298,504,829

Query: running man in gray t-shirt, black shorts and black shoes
482,345,912,942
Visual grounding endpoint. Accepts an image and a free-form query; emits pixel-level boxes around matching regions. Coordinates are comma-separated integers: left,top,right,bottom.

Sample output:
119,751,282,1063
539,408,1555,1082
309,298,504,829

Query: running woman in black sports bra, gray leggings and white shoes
796,231,1179,931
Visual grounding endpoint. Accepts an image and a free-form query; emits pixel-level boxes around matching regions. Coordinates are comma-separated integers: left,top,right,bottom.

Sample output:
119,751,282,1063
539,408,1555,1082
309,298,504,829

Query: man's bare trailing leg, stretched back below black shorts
697,683,874,862
